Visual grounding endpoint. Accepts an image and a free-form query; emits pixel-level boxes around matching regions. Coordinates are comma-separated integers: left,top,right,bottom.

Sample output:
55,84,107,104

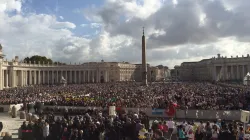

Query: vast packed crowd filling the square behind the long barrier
0,83,249,110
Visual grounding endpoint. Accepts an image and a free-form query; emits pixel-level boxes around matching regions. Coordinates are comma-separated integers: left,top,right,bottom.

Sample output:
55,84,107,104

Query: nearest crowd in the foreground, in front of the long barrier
16,110,245,140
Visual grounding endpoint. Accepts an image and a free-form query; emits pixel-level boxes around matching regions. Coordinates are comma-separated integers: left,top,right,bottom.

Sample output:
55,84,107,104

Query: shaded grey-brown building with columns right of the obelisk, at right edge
174,54,250,81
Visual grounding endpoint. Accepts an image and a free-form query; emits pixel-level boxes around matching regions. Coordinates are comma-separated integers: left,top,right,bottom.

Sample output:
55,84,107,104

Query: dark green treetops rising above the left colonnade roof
24,55,53,64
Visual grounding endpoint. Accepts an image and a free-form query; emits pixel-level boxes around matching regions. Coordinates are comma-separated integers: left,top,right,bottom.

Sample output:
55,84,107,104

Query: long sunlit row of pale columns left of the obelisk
2,69,109,88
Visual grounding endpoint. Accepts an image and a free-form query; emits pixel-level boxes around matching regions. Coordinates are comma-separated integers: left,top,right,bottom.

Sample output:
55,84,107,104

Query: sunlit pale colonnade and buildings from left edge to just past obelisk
0,45,166,90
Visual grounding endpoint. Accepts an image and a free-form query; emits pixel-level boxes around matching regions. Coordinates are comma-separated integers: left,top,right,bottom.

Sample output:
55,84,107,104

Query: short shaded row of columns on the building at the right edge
214,65,250,80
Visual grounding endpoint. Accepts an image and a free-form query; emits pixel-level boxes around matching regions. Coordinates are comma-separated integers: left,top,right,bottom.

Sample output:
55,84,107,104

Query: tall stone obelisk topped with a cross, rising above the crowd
142,27,148,86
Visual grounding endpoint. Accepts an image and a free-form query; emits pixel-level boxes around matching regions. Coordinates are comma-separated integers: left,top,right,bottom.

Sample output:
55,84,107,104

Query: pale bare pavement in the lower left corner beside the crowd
0,113,24,140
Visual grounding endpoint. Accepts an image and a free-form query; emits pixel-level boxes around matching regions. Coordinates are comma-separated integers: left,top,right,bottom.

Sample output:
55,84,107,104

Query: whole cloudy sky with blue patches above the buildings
0,0,250,68
